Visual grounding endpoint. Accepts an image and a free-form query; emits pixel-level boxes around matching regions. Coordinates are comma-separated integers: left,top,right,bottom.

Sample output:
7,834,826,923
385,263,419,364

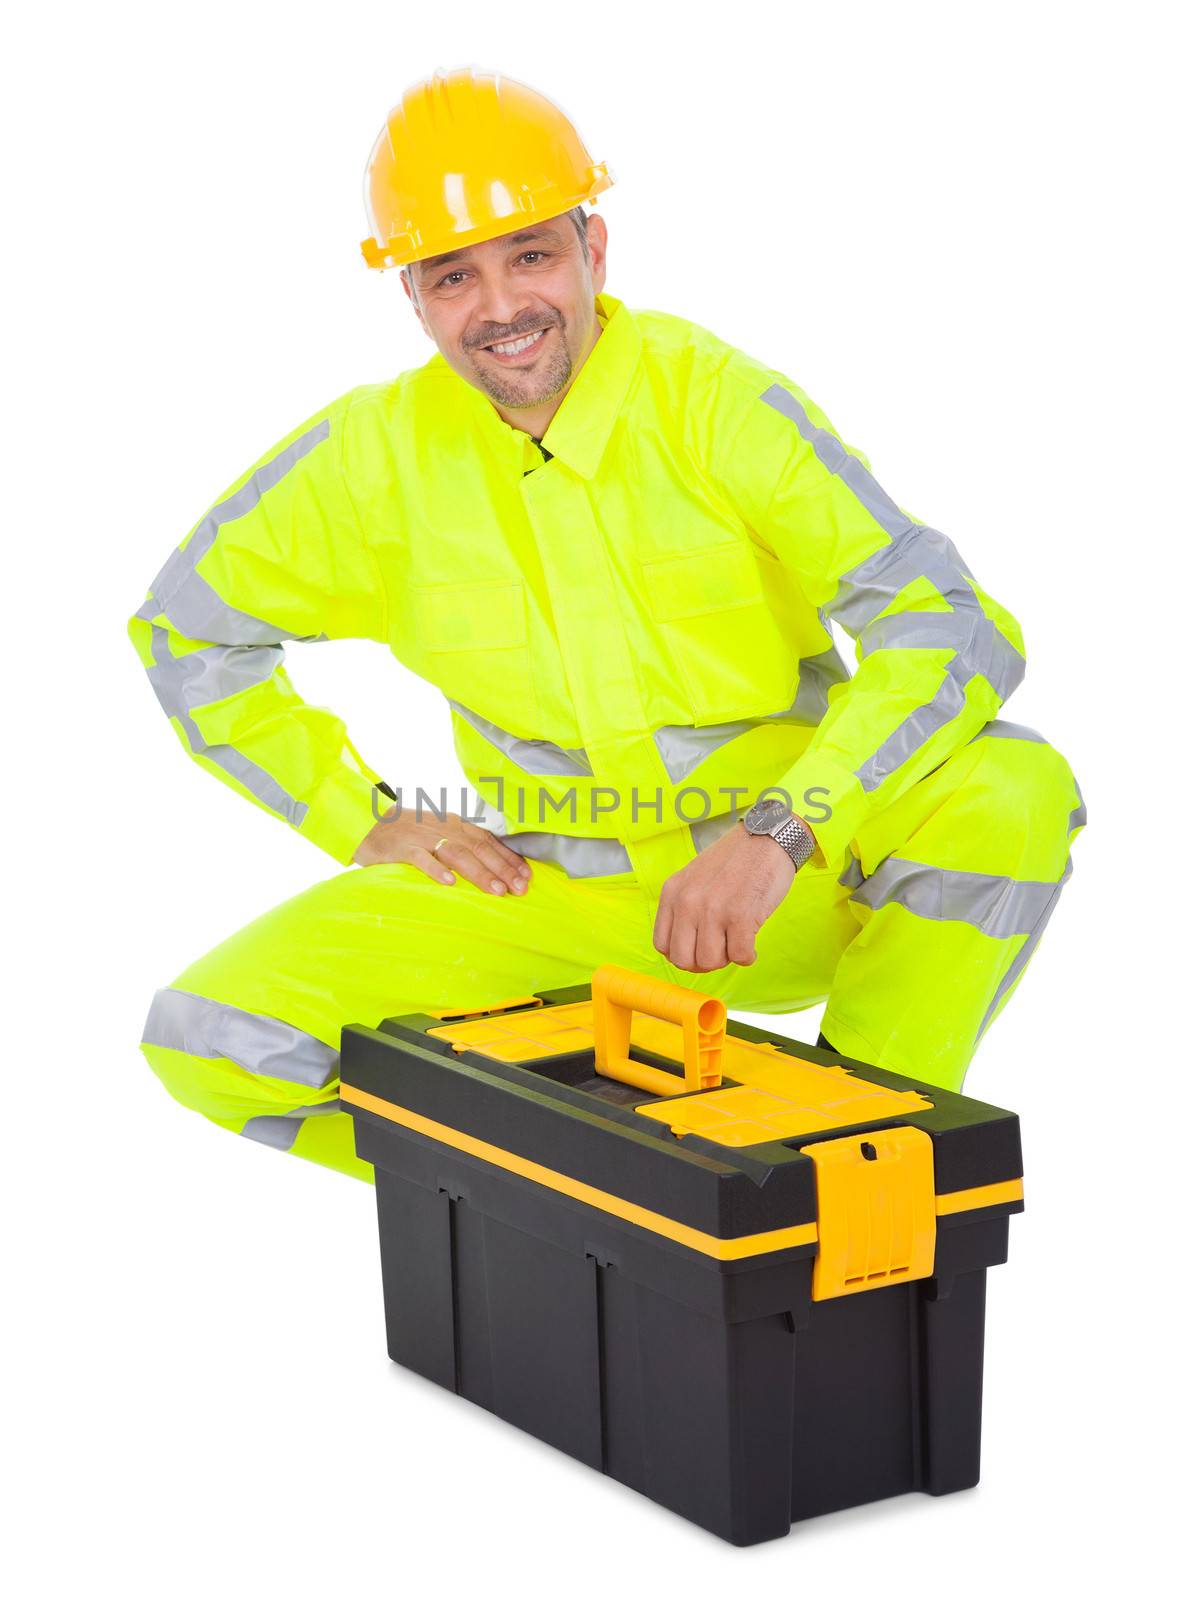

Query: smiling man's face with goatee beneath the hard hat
403,216,606,430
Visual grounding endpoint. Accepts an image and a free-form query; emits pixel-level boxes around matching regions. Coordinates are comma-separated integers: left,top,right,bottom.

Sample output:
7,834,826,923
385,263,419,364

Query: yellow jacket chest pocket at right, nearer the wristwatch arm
641,539,798,723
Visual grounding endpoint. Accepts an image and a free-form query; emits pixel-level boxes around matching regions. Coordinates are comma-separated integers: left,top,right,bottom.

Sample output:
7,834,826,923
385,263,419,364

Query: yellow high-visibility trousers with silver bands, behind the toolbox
142,722,1086,1181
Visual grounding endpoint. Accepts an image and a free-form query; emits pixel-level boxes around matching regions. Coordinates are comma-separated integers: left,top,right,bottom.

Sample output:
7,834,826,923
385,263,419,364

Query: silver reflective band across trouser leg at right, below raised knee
840,856,1057,939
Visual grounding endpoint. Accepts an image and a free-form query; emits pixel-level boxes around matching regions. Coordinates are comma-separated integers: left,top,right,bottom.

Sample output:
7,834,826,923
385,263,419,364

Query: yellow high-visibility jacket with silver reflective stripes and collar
130,294,1024,890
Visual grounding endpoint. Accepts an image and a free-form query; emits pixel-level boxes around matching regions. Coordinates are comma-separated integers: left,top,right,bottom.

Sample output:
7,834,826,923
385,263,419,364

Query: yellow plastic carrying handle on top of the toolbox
590,963,726,1094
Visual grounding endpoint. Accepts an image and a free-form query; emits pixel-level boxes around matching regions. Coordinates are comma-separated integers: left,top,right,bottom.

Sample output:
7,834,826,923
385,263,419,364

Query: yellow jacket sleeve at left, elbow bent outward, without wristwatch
128,392,386,864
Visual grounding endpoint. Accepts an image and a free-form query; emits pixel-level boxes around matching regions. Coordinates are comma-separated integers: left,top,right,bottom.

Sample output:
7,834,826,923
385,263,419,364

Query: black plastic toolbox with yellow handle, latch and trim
341,966,1022,1544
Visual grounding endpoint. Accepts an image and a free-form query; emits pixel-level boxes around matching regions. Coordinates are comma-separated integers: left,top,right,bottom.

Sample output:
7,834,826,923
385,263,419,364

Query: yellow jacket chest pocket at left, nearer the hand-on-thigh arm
406,578,539,738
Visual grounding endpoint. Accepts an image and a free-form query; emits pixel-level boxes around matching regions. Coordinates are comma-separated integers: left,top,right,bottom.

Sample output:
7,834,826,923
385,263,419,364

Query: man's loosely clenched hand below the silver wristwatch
651,822,809,973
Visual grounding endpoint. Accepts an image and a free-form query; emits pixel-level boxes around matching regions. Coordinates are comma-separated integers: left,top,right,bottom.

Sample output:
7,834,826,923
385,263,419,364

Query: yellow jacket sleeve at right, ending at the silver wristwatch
720,366,1025,864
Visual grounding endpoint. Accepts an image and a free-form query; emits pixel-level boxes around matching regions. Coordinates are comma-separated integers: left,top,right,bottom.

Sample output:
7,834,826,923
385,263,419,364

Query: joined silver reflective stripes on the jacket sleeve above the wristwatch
761,384,1025,792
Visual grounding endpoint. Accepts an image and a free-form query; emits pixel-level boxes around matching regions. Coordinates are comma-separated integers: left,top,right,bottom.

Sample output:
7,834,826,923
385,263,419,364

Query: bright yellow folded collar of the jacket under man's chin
429,294,643,478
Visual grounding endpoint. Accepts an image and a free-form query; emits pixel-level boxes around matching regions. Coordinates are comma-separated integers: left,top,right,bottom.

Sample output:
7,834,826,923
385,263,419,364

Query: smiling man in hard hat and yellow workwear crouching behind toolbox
130,72,1085,1179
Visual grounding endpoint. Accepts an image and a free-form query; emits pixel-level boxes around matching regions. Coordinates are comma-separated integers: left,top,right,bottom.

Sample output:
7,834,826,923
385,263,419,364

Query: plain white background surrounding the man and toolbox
0,0,1193,1597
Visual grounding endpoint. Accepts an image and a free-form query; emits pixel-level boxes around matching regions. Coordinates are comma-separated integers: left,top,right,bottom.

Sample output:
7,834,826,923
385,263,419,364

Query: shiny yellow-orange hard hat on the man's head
362,67,614,269
